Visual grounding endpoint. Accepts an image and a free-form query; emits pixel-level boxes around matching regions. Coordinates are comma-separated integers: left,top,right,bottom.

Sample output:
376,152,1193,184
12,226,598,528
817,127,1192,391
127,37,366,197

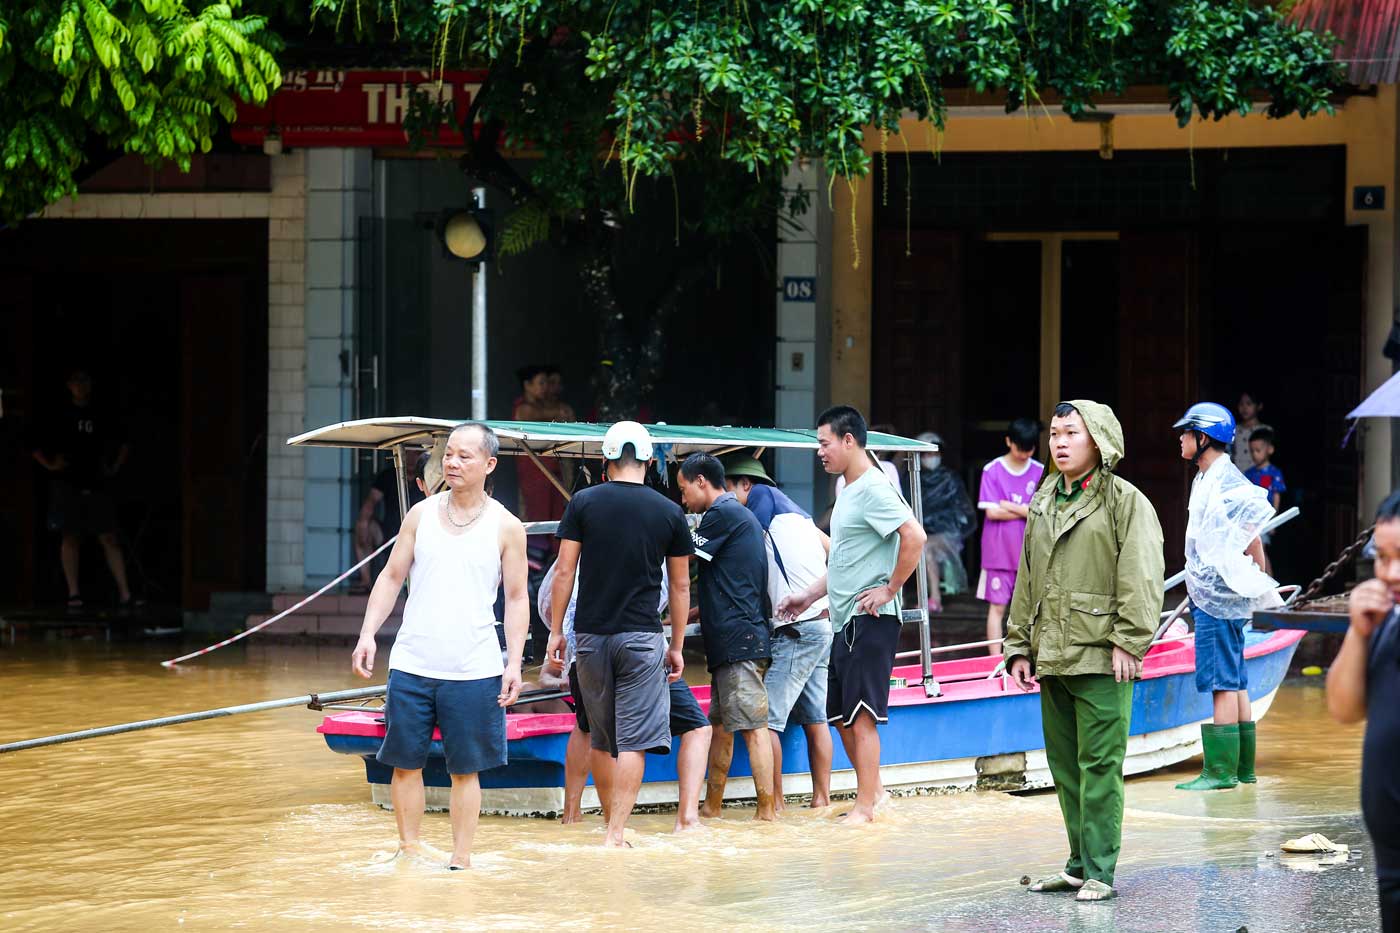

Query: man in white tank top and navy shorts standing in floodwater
350,423,529,870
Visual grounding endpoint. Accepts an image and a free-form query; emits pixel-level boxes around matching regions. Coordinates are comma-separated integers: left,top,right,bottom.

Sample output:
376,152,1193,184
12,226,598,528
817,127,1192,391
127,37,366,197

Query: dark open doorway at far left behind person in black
0,220,267,609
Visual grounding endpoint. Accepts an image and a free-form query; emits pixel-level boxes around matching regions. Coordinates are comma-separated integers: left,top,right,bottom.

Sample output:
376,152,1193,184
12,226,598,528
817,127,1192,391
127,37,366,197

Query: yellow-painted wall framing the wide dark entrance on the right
832,85,1400,509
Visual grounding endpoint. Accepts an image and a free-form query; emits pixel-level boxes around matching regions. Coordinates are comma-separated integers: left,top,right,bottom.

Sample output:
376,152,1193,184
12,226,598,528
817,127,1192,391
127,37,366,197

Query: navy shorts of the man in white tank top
375,671,505,775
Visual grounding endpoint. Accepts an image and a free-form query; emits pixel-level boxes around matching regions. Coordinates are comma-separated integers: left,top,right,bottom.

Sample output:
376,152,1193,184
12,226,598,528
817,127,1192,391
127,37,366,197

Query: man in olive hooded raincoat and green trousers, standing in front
1002,401,1163,901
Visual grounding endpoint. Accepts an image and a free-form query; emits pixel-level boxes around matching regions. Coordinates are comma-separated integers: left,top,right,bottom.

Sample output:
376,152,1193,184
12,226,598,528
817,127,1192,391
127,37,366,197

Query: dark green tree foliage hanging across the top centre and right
314,0,1341,236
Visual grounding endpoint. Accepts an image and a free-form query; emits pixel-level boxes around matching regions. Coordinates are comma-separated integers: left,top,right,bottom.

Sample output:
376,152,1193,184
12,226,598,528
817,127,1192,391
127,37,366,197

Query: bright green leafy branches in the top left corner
0,0,280,223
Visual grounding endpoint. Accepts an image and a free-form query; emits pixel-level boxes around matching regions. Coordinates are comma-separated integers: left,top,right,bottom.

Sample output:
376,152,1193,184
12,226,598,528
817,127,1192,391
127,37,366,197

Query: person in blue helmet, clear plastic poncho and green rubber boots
1172,402,1278,790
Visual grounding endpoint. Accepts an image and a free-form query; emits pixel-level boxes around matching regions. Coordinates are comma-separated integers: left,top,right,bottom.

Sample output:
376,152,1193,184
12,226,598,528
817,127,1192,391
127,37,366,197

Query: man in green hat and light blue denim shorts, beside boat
724,454,832,810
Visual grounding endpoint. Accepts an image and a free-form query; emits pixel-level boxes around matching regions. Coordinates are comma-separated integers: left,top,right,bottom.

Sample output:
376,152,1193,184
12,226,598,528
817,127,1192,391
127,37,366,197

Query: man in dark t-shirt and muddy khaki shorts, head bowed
679,454,777,820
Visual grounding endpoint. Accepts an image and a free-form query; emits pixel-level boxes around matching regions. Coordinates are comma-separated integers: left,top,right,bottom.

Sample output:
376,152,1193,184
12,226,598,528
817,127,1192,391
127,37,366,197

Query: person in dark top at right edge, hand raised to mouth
1327,492,1400,933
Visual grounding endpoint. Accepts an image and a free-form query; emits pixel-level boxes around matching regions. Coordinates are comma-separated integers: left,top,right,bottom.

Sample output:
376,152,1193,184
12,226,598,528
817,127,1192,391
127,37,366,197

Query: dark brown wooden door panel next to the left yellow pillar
867,231,963,461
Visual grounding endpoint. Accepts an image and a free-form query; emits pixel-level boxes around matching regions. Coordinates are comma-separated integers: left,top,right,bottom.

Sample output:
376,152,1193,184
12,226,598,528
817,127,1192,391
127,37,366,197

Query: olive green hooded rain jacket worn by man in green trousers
1002,401,1165,677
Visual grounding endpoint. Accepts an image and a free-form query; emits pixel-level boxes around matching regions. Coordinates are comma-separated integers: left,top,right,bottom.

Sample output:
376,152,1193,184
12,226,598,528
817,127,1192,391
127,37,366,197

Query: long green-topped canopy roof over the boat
287,417,938,457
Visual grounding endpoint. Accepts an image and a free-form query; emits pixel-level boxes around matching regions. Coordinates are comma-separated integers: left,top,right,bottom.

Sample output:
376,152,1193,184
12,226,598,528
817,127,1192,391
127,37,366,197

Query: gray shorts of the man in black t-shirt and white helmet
577,632,671,758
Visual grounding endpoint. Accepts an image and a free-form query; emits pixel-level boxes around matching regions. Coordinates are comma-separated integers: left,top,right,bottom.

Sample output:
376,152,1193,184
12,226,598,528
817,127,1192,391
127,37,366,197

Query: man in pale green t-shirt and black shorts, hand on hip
777,405,927,824
